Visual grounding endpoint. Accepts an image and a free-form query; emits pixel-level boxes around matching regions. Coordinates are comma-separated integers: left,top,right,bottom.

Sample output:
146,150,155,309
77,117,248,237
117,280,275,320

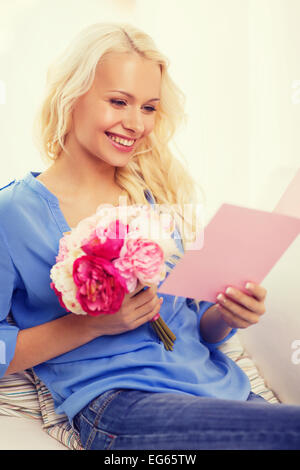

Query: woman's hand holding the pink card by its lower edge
216,282,267,328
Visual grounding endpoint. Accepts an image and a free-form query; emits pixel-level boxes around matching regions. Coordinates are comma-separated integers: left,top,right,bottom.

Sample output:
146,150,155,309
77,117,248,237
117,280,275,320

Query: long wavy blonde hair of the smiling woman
33,23,206,310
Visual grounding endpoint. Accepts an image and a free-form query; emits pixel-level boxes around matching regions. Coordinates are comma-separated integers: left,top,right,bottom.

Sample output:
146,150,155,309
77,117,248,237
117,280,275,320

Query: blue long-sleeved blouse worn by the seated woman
0,172,250,422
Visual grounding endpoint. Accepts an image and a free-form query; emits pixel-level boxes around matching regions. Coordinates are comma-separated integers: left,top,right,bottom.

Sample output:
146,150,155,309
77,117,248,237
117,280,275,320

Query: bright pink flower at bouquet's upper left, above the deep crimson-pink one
81,220,128,260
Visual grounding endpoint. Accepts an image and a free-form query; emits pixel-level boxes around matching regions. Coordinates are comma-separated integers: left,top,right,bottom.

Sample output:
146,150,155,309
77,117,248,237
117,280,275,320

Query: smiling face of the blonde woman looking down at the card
68,53,161,166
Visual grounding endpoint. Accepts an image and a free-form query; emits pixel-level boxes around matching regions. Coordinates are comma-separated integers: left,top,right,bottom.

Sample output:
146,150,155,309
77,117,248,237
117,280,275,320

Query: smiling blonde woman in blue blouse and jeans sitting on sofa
0,24,300,449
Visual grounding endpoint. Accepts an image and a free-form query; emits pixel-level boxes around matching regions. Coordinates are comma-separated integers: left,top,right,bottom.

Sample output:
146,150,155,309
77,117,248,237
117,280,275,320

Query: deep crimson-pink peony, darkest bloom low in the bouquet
73,255,128,316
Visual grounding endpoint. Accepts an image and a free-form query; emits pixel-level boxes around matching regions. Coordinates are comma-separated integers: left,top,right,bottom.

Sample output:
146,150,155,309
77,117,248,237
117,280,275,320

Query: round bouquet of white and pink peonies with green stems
50,204,181,350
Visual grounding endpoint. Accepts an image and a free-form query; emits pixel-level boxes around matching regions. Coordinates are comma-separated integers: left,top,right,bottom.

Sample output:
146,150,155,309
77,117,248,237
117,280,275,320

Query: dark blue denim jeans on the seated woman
73,389,300,450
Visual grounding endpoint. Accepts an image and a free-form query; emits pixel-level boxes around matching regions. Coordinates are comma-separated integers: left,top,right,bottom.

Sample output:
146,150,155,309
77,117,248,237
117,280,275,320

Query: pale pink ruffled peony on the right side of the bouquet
113,238,164,292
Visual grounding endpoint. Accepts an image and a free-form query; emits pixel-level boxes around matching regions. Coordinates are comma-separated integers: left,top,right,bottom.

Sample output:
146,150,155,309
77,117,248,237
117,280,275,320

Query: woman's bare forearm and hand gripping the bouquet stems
5,283,161,375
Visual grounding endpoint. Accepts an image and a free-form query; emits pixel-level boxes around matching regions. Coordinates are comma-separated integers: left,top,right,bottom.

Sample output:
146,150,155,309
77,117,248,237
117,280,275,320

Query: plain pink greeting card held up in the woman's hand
158,204,300,302
